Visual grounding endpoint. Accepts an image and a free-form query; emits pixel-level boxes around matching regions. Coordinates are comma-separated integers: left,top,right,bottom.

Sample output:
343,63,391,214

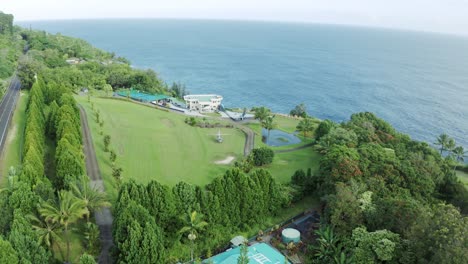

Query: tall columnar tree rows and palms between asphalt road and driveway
0,14,113,263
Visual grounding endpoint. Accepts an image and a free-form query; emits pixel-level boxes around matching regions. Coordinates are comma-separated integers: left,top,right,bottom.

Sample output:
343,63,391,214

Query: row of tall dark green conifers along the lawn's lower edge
113,169,290,263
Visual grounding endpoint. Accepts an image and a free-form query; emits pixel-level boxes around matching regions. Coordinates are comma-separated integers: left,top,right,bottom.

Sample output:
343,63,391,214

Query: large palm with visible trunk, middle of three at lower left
39,191,89,262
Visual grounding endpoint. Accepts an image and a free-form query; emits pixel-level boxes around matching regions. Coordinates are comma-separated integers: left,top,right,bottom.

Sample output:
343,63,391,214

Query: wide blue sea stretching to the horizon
20,20,468,148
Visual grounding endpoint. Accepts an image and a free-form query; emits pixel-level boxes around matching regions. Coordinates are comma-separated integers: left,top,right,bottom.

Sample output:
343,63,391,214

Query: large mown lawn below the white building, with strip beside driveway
76,96,245,197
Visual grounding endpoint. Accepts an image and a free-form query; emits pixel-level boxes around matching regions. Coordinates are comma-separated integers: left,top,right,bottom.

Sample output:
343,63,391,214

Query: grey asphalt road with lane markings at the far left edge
0,76,21,156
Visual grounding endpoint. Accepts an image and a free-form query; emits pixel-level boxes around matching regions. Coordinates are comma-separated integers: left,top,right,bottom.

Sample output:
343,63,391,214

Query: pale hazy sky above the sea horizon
0,0,468,35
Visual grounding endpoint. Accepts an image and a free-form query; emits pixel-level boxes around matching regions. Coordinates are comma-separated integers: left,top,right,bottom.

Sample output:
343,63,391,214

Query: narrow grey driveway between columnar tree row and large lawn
79,105,113,263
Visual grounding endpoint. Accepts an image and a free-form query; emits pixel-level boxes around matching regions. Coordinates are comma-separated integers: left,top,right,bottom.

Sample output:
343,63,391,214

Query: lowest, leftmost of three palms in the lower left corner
27,215,64,259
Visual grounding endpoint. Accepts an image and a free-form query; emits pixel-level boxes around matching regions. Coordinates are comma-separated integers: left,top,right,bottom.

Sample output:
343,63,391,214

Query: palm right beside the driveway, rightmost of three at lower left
71,176,111,222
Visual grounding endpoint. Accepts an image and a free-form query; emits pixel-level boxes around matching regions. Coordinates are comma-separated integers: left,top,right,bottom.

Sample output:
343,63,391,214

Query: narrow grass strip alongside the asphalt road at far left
0,91,29,186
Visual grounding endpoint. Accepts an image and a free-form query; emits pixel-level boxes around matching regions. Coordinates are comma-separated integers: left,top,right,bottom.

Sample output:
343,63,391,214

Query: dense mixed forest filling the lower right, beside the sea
302,113,468,263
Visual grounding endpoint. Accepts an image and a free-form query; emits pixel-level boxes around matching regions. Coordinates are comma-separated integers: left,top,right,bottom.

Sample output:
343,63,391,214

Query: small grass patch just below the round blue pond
265,147,321,183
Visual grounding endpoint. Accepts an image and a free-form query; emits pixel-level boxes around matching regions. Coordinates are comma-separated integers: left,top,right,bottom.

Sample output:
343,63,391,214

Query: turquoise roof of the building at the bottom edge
203,243,291,264
